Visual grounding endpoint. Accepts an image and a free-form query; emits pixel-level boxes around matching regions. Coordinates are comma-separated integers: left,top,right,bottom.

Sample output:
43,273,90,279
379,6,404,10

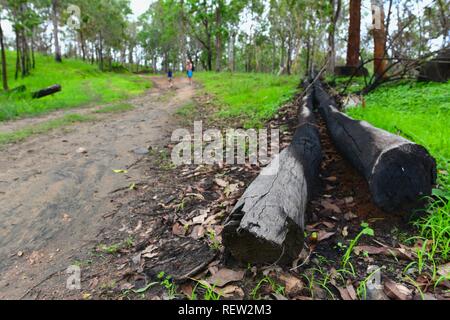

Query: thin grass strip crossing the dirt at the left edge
0,114,95,145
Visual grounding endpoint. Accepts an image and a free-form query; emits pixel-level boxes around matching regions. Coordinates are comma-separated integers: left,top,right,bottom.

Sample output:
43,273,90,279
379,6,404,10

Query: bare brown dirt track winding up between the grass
0,78,194,299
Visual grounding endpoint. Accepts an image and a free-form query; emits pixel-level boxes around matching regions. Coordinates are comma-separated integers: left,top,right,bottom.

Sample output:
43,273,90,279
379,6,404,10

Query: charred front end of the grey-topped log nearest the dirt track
223,218,304,265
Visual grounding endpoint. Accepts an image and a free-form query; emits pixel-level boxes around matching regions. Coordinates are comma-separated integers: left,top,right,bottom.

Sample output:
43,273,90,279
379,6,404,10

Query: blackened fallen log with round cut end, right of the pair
314,83,437,211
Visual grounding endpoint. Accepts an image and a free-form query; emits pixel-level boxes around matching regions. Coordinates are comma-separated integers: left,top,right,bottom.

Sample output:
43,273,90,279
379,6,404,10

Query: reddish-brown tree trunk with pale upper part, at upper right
371,0,386,78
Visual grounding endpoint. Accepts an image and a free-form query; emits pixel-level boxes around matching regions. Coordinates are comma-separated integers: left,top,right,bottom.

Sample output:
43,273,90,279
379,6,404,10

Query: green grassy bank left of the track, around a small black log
0,52,151,121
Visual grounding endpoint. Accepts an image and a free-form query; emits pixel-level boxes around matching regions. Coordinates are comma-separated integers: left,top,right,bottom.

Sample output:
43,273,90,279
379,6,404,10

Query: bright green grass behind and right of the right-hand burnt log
347,82,450,261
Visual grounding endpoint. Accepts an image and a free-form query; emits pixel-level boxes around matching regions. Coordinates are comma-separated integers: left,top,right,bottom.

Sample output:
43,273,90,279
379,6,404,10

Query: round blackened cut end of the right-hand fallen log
369,143,437,211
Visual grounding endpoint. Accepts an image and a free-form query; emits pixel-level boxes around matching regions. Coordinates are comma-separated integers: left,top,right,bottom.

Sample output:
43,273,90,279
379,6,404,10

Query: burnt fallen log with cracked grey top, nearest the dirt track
222,88,322,264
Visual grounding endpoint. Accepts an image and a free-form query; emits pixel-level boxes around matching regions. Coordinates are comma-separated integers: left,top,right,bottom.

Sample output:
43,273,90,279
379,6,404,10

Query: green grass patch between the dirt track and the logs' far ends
195,72,300,128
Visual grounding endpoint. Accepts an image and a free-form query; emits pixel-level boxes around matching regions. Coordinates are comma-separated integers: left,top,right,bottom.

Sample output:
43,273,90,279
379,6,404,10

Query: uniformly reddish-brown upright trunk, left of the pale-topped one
347,0,361,68
